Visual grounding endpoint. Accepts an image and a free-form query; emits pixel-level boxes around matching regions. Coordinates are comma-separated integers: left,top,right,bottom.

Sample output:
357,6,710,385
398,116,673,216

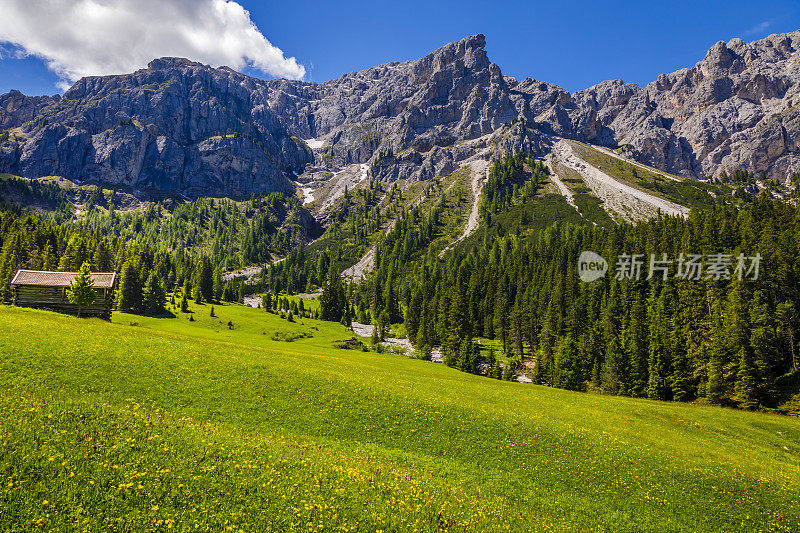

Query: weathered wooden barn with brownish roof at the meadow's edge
11,270,116,320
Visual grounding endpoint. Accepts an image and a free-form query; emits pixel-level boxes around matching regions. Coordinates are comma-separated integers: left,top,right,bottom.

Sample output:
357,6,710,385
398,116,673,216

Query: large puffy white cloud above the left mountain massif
0,0,305,88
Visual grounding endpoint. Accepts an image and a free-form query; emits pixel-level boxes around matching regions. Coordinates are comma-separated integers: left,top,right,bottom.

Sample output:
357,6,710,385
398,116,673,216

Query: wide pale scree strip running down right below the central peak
553,139,689,221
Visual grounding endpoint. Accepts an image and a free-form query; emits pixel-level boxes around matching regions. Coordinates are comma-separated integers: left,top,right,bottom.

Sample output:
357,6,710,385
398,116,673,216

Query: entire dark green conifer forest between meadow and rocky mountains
0,155,800,408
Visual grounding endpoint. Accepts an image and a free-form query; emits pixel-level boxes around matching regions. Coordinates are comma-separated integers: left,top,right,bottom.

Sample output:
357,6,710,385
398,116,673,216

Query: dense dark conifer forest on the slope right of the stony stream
276,156,800,408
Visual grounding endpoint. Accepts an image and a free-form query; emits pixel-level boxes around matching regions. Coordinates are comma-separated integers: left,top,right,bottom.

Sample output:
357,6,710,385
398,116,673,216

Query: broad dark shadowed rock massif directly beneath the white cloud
0,59,312,197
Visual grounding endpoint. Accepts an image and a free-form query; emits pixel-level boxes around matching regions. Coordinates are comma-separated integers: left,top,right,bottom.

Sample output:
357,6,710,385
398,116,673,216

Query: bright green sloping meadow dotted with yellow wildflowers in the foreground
0,305,800,532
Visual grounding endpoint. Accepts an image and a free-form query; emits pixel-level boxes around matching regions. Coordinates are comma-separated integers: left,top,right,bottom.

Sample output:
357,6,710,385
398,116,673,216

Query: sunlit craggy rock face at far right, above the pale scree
575,31,800,180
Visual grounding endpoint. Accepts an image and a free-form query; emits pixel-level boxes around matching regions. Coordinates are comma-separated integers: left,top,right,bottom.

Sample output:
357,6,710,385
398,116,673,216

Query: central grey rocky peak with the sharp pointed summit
267,35,518,179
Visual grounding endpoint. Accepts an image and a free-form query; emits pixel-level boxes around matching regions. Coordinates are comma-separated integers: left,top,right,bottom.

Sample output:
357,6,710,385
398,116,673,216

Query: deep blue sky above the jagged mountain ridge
0,0,800,94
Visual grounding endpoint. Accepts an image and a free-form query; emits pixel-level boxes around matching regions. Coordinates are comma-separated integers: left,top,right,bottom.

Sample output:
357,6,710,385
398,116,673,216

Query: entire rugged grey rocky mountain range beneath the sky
0,31,800,200
